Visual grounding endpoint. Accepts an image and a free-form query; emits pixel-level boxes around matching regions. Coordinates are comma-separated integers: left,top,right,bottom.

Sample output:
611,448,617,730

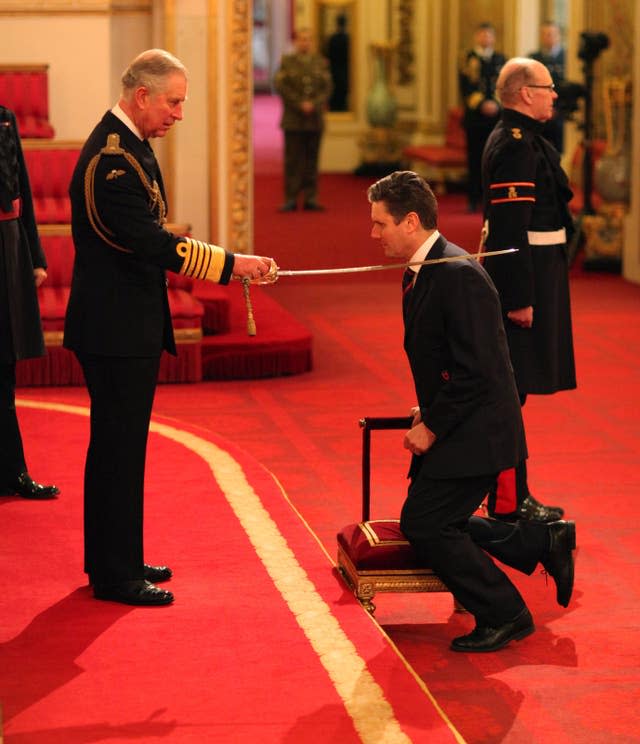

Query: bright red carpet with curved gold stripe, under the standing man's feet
0,401,454,744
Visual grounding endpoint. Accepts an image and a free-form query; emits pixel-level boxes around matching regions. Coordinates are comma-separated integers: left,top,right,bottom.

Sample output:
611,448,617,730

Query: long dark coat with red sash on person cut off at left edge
0,106,47,364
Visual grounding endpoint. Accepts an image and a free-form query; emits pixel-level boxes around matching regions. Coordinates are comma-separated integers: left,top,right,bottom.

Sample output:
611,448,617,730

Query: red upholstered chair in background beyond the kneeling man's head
402,108,467,194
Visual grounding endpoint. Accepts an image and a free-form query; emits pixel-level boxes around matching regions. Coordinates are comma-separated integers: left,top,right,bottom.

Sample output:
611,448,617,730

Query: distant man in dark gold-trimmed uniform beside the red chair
458,23,505,211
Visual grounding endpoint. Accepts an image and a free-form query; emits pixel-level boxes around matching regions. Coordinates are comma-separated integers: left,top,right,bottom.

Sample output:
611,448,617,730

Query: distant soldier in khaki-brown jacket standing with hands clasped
274,29,332,212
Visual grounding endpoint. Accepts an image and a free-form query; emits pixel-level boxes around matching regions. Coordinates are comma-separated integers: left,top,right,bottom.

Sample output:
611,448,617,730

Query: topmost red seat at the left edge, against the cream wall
0,64,54,139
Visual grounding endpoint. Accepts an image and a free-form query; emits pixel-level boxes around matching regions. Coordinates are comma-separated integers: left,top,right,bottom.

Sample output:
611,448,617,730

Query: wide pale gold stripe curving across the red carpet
16,400,463,744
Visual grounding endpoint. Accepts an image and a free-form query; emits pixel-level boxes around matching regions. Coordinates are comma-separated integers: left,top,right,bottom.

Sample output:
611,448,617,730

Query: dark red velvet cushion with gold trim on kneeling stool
338,519,424,571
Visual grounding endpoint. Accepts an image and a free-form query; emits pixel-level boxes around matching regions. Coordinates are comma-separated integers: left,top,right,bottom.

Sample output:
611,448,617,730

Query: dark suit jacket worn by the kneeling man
404,236,527,478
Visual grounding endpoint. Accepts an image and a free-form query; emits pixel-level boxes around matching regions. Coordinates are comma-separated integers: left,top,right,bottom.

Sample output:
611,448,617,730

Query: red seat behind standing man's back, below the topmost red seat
23,140,80,225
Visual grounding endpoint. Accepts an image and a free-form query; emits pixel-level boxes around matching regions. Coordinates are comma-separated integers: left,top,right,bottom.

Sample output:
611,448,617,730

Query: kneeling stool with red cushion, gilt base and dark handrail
338,417,460,614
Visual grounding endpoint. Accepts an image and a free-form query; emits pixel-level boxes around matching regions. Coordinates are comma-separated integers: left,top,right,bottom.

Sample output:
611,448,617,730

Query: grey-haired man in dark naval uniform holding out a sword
64,49,272,605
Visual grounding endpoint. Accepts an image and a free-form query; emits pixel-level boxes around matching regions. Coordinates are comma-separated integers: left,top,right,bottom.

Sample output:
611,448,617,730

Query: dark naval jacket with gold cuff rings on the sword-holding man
64,111,233,357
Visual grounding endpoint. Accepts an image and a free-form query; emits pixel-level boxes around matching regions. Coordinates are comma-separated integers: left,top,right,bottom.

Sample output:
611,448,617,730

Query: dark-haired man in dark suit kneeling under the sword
368,171,575,651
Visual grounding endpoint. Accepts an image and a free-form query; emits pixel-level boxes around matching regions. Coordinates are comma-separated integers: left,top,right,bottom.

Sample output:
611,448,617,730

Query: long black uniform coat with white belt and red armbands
482,109,576,394
